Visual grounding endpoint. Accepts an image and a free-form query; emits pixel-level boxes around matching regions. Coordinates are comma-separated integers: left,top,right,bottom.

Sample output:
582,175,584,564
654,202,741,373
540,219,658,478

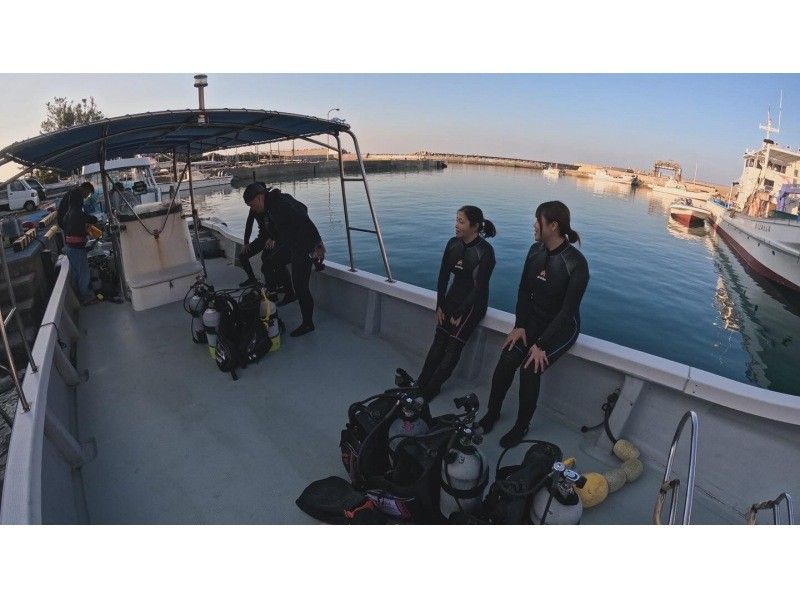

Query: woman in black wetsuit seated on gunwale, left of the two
417,206,497,401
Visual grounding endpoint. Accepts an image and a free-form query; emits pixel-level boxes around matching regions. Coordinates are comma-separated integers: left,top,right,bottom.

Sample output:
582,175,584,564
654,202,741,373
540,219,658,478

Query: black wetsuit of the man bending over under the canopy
266,189,322,325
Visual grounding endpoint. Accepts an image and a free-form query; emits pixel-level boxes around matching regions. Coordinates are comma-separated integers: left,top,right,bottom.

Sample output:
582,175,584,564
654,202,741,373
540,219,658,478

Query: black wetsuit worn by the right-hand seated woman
488,241,589,428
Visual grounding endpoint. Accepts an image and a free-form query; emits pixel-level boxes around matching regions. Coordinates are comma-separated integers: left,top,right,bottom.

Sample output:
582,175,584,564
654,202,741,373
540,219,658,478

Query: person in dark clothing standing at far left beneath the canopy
58,183,97,305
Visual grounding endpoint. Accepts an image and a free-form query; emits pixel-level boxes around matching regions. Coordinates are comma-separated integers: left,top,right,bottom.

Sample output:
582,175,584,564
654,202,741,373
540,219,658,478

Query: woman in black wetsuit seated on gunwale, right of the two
478,201,589,448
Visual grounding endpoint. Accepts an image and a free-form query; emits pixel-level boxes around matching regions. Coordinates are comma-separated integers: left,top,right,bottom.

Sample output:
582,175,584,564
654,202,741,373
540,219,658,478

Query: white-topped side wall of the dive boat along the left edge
0,255,94,524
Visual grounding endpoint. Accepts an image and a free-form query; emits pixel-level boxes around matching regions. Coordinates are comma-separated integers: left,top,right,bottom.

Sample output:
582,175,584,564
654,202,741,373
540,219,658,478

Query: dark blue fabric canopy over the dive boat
0,109,350,171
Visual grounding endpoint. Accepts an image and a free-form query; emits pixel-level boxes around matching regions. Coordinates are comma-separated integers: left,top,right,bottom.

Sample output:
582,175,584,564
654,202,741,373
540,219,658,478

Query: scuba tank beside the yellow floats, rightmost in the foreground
530,461,586,525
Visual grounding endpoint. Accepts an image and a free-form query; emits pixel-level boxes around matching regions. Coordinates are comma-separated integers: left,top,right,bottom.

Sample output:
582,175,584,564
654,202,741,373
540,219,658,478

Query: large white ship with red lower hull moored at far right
708,113,800,292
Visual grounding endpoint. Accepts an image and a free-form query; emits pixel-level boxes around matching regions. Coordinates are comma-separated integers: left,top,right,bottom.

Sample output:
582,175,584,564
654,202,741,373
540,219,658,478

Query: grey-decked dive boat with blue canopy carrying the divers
0,96,800,524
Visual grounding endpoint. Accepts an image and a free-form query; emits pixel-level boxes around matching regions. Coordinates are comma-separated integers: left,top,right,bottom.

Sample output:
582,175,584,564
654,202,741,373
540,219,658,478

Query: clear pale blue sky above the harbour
0,73,800,184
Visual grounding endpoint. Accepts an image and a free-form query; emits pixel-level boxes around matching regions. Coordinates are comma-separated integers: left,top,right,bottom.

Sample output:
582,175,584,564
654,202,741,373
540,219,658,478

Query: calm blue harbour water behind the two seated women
184,166,800,394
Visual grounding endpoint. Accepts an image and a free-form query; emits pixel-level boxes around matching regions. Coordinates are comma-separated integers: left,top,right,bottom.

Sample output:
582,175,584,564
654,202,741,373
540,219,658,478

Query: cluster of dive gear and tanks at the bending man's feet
183,277,285,380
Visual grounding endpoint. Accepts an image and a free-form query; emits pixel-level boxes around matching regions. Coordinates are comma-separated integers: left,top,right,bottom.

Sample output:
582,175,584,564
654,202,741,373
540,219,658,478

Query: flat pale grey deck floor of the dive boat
77,259,737,524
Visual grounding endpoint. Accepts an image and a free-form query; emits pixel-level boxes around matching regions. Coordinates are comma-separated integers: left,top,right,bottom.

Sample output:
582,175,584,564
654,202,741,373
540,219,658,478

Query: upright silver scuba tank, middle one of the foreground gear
439,394,489,519
